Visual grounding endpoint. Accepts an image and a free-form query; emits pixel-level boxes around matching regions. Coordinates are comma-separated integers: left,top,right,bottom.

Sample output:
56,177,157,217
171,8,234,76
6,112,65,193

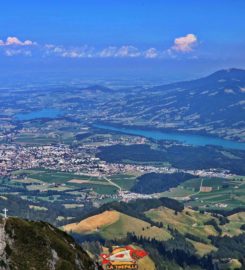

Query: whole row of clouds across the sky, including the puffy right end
0,34,197,59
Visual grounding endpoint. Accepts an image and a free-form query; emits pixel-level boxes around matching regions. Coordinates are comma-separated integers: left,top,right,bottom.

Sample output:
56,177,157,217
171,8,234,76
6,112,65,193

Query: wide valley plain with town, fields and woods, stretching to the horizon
0,77,245,224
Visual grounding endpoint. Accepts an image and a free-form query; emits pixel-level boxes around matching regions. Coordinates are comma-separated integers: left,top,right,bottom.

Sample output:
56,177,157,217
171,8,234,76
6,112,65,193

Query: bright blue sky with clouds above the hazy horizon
0,0,245,81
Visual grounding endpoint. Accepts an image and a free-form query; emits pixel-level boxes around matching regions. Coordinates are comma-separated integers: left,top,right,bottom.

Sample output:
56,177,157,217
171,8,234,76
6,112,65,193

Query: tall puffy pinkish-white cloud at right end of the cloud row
170,34,197,53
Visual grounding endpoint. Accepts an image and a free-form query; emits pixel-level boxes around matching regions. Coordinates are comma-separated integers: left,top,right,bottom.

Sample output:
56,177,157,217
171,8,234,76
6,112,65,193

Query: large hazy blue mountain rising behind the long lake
97,69,245,141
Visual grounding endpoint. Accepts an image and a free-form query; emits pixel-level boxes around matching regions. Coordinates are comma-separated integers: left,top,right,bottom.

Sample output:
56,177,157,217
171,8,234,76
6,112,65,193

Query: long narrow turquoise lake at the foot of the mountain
94,124,245,150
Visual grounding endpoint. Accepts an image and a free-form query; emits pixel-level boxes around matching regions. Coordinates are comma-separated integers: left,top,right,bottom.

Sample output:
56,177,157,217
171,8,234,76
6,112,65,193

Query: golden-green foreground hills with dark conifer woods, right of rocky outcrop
64,198,245,270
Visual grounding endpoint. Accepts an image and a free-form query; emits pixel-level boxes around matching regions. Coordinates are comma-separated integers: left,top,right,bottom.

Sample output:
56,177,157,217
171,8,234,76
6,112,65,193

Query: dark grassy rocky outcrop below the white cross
0,218,95,270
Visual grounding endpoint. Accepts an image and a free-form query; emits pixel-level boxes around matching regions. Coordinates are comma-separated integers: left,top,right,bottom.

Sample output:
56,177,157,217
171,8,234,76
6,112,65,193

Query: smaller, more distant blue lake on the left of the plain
15,108,62,121
